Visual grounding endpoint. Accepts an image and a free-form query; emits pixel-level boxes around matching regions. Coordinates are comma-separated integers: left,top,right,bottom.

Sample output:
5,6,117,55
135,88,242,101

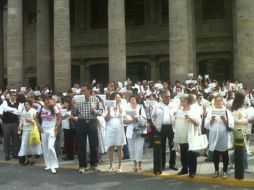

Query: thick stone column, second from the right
169,0,196,83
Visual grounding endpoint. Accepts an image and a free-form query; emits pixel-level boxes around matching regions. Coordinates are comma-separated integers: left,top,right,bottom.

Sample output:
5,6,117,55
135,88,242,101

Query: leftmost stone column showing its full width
6,0,24,87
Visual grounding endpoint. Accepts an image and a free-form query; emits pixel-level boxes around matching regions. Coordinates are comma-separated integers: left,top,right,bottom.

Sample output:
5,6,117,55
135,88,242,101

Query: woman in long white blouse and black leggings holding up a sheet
205,96,234,179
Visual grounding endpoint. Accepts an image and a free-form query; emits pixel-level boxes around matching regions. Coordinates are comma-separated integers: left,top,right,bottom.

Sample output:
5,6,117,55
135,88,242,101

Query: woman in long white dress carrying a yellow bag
18,100,42,165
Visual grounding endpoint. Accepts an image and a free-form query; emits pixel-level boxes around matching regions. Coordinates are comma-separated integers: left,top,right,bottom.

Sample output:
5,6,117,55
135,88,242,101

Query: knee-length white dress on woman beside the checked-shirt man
105,109,126,149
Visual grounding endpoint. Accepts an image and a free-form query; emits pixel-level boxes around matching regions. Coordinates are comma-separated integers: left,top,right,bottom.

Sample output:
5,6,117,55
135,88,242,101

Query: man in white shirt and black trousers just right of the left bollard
159,89,178,170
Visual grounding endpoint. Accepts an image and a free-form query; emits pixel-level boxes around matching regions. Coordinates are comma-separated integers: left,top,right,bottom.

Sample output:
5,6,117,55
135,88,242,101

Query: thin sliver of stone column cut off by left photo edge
0,1,4,89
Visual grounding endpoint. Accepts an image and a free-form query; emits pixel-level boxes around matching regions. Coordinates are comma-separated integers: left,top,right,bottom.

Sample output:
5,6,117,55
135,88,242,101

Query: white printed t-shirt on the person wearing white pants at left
37,106,59,129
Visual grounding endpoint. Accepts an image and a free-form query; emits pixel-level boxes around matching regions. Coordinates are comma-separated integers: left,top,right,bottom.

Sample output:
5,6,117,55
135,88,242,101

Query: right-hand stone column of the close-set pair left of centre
54,0,71,92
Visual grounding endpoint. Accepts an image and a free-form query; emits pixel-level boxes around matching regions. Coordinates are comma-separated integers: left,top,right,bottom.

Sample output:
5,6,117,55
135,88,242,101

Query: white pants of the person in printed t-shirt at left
42,127,59,168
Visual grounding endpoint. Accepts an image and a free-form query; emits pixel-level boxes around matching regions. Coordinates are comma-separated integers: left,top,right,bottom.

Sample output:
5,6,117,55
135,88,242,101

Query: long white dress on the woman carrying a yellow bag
18,108,42,156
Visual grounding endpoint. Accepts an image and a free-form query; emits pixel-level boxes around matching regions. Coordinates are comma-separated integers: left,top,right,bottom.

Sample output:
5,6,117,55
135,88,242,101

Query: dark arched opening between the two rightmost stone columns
199,59,233,81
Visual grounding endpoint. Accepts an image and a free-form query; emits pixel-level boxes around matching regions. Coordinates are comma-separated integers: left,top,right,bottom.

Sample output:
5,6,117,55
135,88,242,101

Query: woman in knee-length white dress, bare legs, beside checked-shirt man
105,93,126,173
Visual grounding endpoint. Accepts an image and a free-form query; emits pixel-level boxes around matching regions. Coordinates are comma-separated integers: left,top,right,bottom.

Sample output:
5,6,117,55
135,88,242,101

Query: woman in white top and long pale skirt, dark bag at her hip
124,96,146,173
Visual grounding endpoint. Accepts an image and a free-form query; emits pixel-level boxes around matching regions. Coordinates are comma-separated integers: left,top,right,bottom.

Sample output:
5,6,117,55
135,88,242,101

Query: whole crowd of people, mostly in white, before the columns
0,76,254,179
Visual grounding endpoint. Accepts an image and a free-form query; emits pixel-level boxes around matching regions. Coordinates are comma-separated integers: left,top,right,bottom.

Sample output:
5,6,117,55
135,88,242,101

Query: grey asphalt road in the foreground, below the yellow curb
0,164,251,190
